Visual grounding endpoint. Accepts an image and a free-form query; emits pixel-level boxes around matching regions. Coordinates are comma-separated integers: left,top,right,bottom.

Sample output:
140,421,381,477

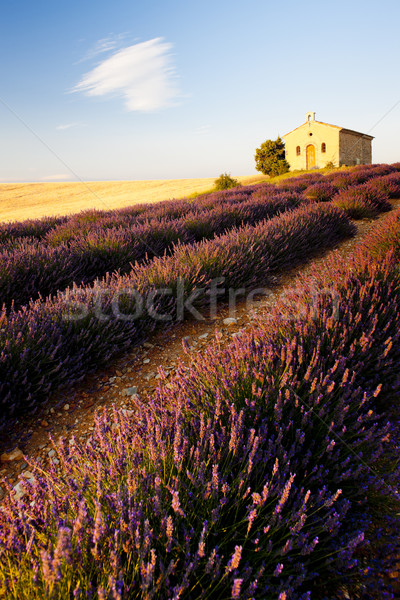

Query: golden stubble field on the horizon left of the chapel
0,175,268,222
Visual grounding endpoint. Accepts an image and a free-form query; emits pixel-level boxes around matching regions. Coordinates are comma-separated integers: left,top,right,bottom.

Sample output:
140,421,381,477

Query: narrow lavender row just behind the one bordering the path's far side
0,190,302,308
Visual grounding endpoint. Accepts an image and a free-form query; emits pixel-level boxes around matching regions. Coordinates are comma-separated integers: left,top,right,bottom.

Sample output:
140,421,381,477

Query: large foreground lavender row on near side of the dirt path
0,207,400,600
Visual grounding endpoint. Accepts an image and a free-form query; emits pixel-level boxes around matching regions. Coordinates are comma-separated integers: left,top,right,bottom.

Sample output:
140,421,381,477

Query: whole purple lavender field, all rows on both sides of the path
0,164,400,600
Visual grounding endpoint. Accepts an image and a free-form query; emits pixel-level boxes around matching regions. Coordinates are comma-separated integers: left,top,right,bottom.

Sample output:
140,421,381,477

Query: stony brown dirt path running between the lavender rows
0,199,400,498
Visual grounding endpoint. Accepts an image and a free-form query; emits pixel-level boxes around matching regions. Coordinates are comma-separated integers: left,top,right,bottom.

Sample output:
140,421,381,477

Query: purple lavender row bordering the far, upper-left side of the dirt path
0,204,354,434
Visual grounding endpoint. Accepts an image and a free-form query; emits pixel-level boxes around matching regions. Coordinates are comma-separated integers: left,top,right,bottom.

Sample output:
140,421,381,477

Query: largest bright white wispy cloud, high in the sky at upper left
73,38,178,111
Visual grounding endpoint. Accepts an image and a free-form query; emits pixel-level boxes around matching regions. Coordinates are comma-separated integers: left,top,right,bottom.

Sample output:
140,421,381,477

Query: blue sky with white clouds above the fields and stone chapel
0,0,400,182
